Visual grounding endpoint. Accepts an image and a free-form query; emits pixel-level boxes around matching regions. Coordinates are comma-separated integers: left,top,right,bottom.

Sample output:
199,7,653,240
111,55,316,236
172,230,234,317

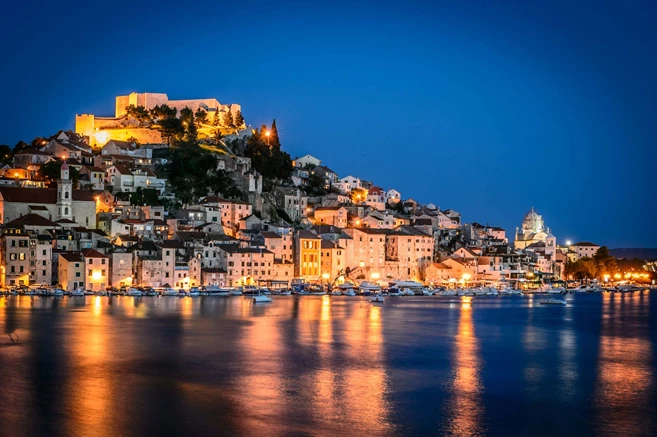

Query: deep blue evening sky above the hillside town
0,0,657,247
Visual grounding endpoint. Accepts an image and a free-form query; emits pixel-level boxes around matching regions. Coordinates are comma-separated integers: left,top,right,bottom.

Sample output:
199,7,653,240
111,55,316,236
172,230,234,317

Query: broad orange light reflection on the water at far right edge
595,293,655,436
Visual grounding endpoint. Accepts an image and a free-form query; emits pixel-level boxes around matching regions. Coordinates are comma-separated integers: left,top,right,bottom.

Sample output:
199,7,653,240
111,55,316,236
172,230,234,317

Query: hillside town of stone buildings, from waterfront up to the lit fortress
0,93,599,291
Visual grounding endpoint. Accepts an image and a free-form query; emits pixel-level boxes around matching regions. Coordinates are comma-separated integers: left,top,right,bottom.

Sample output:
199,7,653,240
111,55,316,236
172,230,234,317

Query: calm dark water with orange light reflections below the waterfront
0,292,657,436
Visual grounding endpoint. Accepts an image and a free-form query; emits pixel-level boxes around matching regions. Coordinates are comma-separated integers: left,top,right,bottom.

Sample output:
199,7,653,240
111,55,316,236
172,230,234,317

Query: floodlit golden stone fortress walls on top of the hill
75,93,242,147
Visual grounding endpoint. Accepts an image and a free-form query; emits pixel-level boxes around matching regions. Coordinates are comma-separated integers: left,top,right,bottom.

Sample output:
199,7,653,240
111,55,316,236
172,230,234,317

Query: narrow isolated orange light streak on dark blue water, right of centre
444,297,483,436
